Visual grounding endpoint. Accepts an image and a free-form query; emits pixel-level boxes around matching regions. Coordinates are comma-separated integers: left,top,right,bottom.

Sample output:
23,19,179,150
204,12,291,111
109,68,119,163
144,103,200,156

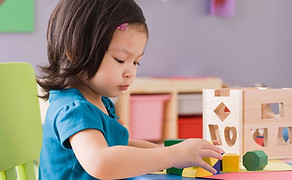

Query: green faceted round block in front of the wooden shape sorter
243,150,268,171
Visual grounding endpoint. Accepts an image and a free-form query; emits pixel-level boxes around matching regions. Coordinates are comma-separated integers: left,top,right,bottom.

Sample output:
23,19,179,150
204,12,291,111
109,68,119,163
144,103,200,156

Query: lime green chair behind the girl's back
0,63,42,180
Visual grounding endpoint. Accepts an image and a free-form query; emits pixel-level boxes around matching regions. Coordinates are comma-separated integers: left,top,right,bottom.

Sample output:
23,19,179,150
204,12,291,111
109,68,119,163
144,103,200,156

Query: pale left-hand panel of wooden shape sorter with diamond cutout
203,89,242,154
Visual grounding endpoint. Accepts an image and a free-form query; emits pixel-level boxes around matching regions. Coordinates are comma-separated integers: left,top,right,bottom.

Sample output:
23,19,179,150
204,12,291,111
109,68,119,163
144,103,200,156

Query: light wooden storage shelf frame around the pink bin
115,77,223,141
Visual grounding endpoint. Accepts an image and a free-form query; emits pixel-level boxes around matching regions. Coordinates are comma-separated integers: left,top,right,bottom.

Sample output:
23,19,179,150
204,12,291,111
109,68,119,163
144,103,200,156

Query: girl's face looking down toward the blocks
82,25,147,97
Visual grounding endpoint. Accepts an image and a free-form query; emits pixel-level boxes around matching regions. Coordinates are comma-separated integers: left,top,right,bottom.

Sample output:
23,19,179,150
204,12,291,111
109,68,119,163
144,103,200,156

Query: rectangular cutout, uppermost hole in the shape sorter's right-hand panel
261,103,284,119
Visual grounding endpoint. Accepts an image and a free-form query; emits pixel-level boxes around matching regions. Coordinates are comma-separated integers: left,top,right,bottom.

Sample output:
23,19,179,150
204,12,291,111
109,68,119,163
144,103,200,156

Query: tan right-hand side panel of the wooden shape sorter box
243,89,292,159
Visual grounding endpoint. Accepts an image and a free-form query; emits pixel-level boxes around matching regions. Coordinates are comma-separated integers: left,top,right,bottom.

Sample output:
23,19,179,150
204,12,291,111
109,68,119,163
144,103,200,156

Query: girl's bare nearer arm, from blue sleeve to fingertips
69,129,223,179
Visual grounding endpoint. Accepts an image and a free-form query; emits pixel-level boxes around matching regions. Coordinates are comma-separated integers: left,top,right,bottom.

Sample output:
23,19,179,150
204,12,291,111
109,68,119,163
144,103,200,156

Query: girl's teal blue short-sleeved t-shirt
39,88,129,180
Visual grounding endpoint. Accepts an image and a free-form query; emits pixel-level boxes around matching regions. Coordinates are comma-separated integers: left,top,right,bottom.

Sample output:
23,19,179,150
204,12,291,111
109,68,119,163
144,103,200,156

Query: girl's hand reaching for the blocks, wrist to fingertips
170,139,224,174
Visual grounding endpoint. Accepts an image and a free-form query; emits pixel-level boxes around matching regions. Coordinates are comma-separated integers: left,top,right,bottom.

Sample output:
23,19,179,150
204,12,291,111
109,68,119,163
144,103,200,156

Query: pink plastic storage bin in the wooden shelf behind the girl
130,95,170,141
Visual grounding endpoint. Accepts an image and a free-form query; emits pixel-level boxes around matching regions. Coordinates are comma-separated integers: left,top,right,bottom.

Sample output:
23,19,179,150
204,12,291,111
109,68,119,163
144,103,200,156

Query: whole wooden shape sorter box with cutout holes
203,88,292,159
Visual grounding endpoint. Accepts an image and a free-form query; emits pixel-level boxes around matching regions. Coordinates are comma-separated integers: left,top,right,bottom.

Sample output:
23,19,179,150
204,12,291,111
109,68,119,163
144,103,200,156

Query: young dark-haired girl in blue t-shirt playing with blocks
38,0,222,180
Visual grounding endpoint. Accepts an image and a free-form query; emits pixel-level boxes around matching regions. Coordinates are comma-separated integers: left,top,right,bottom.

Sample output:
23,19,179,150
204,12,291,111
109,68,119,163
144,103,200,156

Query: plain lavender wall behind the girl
0,0,292,88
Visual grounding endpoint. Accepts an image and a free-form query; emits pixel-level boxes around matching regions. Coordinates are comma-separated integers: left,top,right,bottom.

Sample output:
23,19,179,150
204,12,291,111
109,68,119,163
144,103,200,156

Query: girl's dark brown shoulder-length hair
37,0,148,99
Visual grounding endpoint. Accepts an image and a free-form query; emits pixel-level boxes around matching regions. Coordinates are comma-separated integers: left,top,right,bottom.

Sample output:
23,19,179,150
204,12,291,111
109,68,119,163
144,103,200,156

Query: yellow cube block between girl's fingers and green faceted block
222,153,240,172
